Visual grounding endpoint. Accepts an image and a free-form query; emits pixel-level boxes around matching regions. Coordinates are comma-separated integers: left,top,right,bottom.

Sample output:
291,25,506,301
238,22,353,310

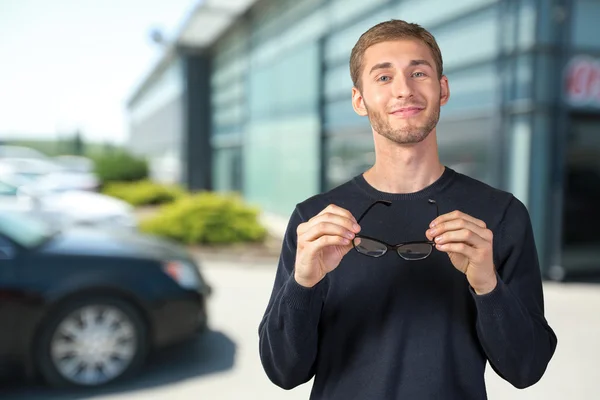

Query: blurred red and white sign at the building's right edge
565,56,600,108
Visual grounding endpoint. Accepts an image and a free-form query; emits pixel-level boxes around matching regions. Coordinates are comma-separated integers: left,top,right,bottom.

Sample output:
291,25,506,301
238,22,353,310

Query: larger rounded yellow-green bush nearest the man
140,192,267,244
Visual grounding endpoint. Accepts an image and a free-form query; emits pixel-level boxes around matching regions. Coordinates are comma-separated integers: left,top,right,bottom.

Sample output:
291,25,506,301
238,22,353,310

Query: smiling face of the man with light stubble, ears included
352,40,449,144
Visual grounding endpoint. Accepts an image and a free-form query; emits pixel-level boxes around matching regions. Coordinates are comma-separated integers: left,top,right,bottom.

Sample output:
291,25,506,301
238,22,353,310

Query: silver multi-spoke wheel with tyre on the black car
38,298,147,387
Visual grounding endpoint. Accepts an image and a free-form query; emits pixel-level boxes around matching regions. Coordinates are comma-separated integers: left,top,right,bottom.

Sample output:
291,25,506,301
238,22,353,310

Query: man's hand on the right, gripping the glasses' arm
425,211,497,294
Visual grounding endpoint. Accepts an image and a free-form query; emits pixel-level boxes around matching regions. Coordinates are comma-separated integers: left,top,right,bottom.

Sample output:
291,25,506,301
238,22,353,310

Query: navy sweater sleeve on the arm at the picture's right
470,197,557,389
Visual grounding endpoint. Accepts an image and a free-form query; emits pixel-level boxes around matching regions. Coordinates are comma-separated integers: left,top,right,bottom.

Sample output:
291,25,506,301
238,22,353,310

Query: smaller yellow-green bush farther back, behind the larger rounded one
102,180,185,207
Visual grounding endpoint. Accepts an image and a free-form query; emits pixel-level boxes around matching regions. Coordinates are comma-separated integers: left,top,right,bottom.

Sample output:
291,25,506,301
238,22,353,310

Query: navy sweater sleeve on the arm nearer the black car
259,208,328,389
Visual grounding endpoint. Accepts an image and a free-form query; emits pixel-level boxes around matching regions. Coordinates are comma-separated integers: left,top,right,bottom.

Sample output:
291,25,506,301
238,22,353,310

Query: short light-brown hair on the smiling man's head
350,19,444,90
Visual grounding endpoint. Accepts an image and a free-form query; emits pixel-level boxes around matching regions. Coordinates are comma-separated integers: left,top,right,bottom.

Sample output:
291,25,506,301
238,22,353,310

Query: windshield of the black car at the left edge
0,213,58,248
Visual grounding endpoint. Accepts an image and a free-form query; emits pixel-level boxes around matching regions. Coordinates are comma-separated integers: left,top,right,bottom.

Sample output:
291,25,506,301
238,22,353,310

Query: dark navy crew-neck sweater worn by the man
259,168,557,400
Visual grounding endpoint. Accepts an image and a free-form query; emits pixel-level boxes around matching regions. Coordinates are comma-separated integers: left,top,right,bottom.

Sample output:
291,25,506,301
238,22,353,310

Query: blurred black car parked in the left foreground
0,214,210,387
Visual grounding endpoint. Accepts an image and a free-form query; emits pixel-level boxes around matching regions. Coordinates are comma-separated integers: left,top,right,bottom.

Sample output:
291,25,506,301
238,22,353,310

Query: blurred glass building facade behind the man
126,0,600,278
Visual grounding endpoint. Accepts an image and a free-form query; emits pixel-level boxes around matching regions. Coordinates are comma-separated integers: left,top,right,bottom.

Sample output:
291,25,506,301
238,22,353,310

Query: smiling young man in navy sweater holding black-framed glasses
259,20,557,400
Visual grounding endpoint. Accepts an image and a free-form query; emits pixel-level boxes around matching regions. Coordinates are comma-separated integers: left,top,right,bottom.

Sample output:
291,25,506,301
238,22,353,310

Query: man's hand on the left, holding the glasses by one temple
294,204,360,287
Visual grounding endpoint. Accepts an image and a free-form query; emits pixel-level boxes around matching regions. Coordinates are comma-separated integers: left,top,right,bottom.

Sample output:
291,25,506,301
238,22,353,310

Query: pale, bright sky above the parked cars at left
0,0,198,143
